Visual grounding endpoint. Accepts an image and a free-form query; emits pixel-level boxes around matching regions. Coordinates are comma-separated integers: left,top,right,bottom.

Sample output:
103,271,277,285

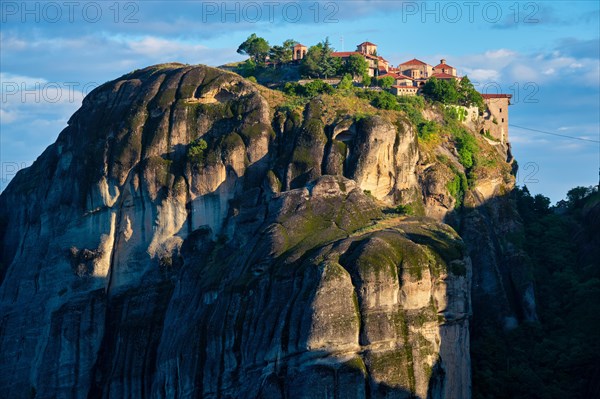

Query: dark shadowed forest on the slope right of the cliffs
471,187,600,399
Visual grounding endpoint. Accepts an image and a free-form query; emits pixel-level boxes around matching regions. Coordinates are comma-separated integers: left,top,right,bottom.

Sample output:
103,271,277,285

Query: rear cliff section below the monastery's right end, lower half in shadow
417,119,537,329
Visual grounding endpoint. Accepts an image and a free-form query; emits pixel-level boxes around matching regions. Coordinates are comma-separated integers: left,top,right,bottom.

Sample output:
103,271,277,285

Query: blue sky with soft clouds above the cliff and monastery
0,0,600,202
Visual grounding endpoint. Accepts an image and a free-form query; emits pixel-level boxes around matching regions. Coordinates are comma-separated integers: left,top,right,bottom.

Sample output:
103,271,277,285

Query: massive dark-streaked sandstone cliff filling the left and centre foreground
0,65,472,398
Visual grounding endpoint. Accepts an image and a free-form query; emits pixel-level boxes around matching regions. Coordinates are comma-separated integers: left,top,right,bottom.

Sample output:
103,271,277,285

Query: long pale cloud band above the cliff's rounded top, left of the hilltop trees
0,32,243,86
